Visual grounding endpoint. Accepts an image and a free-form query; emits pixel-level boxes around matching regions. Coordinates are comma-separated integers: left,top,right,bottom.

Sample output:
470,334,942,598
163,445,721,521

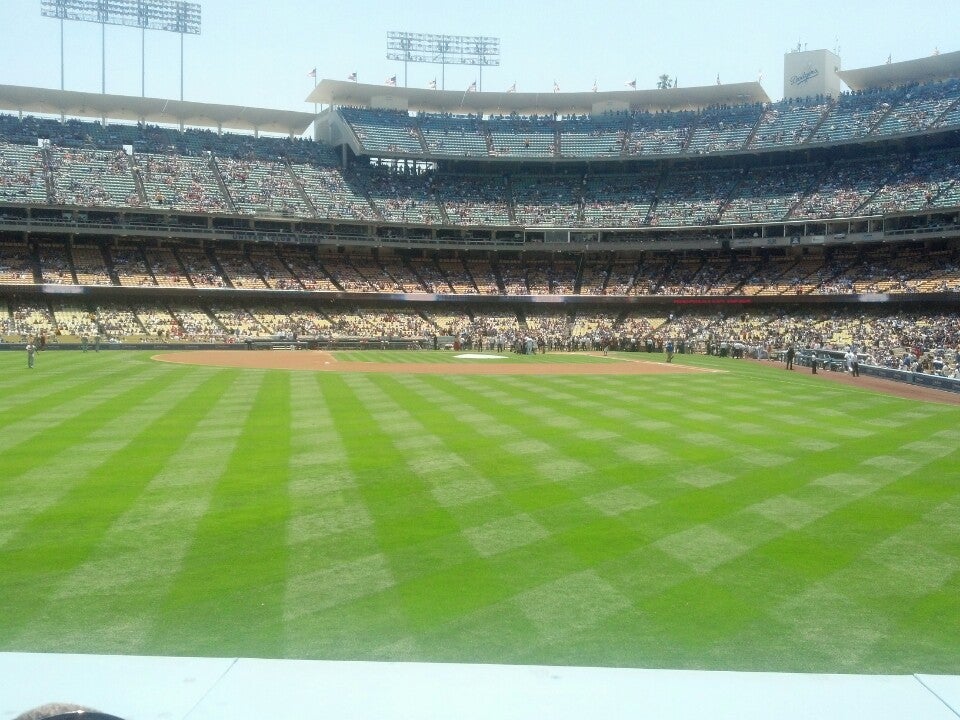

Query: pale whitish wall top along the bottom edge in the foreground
0,653,960,720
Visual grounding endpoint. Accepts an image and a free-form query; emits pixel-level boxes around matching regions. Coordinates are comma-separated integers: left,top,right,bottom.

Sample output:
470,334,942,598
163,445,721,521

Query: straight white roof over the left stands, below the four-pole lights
0,85,314,135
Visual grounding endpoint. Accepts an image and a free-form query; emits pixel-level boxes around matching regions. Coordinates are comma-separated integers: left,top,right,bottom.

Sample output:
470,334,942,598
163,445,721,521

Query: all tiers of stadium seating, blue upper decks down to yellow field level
0,71,960,364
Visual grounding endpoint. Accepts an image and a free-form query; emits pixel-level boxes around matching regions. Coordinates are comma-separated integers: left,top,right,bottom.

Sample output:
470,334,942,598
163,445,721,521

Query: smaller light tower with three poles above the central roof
387,30,500,90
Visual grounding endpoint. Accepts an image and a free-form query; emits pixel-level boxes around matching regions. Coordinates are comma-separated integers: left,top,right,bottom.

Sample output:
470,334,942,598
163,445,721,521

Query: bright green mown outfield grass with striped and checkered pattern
0,351,960,674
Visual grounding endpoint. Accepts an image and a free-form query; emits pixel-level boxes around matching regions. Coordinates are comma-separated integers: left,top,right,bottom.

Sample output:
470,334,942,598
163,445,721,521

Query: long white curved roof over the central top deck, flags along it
307,80,770,115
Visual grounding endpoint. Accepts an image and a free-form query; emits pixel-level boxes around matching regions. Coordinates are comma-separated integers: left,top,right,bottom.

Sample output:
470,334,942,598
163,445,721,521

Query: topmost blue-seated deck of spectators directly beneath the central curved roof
339,80,960,158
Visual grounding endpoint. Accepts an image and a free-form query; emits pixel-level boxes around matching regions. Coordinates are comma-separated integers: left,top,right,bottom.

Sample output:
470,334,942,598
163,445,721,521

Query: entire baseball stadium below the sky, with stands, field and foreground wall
0,7,960,720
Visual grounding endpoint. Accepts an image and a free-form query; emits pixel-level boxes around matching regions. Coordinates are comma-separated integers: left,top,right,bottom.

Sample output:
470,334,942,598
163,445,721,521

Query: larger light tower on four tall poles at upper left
40,0,200,100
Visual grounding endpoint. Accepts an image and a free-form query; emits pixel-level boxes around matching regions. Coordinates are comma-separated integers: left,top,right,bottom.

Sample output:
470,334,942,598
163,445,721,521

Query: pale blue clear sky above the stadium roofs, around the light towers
0,0,960,111
